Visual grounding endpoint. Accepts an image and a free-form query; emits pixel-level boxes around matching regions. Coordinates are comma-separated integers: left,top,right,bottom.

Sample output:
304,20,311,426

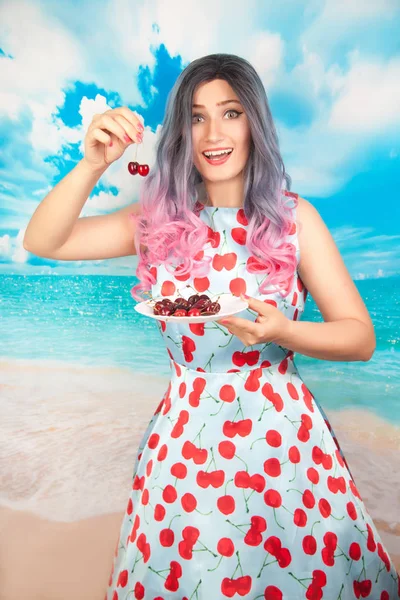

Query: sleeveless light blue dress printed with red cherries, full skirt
106,192,400,600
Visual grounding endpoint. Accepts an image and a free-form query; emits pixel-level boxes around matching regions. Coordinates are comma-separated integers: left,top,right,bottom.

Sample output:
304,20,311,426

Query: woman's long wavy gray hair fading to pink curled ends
130,54,298,301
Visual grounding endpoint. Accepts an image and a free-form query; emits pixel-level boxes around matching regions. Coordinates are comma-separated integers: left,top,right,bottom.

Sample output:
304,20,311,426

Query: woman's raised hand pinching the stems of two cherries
84,106,144,170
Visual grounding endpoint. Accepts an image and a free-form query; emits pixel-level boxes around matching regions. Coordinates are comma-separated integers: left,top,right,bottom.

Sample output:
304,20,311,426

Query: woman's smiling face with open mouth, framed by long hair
192,79,251,181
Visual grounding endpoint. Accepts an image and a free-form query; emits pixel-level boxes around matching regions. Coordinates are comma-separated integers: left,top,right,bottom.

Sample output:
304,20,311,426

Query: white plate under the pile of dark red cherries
135,290,248,323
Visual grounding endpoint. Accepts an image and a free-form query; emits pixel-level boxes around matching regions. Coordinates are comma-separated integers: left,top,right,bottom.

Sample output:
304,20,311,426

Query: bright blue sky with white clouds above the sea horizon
0,0,400,280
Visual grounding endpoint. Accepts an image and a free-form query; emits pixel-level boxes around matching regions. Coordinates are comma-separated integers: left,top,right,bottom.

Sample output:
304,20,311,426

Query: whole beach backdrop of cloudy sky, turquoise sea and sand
0,0,400,600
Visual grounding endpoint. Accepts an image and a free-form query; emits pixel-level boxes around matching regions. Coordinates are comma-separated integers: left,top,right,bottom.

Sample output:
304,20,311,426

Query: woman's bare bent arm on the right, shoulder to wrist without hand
276,197,376,361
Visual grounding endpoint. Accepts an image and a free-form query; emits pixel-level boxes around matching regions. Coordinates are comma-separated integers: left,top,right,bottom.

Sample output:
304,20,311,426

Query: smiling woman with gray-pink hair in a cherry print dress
25,54,400,600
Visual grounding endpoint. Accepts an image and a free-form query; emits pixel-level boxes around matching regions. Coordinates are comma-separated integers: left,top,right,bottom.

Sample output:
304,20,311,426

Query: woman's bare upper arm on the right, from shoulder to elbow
296,196,373,329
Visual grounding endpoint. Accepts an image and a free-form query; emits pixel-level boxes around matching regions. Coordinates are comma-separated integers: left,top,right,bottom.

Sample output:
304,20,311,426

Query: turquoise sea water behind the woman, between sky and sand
0,274,400,423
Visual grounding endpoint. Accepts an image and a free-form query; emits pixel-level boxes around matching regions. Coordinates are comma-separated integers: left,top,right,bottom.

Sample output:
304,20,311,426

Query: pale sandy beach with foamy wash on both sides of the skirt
0,361,400,600
